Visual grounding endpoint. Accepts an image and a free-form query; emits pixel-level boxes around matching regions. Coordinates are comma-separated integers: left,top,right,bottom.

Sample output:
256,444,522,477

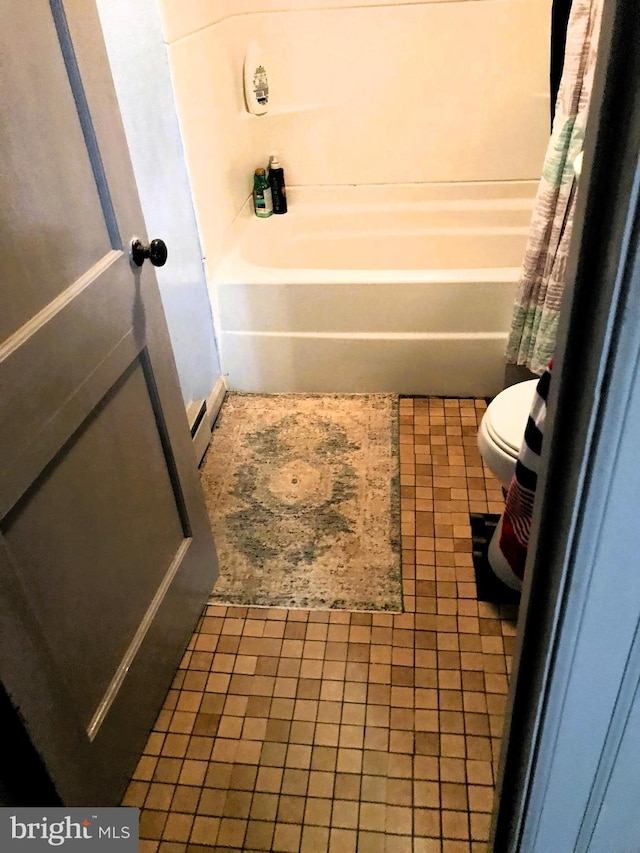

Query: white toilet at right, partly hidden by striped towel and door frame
478,379,538,589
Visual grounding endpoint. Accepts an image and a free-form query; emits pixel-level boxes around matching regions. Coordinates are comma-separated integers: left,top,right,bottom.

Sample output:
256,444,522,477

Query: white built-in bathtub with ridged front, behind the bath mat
212,181,536,396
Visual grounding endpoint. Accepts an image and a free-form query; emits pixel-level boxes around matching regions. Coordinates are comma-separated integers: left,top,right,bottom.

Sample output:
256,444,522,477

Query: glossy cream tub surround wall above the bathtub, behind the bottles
158,0,550,260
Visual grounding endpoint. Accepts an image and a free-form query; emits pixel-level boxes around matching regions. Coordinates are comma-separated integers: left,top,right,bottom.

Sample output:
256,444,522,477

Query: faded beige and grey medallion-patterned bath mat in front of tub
201,393,402,611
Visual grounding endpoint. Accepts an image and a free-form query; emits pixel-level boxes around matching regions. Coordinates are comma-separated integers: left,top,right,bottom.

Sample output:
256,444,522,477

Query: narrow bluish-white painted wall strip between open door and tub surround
97,0,220,404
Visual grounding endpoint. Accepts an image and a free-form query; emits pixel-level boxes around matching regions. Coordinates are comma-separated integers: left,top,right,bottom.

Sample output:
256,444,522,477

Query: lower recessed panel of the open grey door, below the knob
1,359,185,727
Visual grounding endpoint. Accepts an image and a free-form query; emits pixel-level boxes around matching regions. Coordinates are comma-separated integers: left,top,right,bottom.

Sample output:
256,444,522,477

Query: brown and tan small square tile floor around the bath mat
123,399,516,853
